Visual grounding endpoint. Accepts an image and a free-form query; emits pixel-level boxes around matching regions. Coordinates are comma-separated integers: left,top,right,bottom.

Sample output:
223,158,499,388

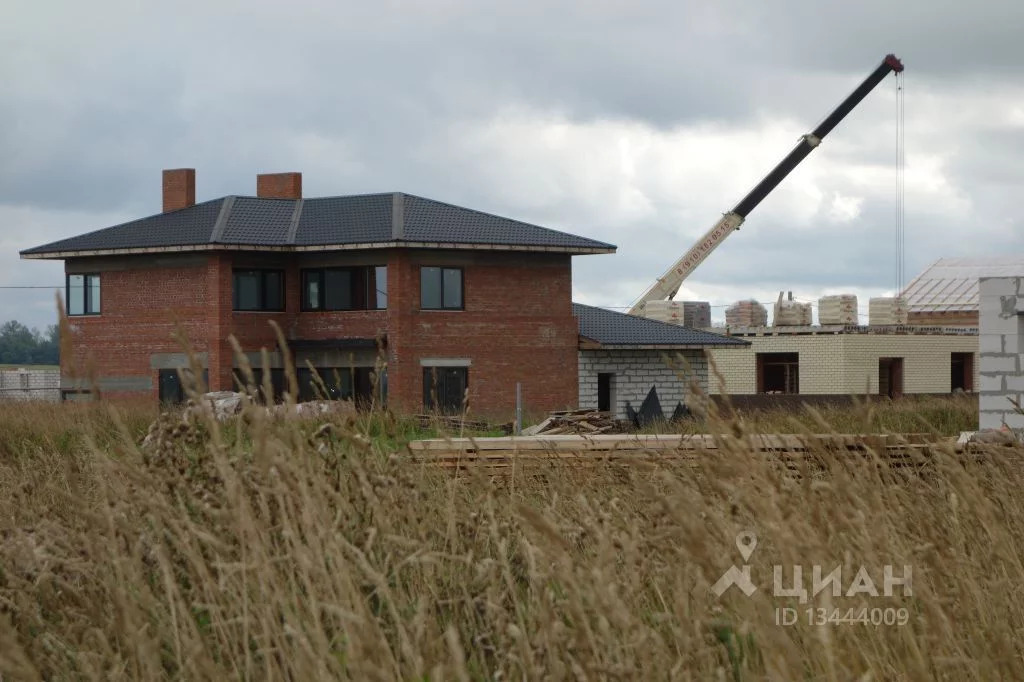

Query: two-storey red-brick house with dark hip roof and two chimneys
22,169,745,415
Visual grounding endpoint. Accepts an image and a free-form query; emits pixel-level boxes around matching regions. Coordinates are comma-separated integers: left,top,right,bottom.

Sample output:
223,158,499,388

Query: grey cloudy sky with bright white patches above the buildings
0,0,1024,326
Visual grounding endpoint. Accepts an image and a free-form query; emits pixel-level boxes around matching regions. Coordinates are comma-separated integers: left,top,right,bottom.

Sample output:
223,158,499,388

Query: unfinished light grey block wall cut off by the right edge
978,276,1024,429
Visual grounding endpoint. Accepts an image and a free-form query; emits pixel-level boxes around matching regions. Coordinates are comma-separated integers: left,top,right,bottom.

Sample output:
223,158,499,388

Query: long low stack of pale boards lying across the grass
409,434,995,473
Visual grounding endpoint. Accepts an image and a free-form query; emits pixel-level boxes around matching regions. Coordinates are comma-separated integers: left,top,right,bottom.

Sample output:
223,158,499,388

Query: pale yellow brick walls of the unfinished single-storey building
710,333,978,395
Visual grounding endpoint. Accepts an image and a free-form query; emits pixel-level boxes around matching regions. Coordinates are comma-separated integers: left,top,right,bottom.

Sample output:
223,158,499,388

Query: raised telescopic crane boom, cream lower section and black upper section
629,54,903,317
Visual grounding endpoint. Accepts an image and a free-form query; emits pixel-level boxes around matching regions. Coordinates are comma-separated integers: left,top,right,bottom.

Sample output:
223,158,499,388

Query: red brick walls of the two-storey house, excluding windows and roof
62,249,579,418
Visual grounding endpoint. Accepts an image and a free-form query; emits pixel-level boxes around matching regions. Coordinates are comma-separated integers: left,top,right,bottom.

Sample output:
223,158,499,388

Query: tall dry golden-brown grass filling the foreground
0,391,1024,681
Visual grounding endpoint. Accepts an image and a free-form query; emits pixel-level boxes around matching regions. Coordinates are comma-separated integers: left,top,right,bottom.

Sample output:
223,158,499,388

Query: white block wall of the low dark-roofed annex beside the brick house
579,350,708,419
